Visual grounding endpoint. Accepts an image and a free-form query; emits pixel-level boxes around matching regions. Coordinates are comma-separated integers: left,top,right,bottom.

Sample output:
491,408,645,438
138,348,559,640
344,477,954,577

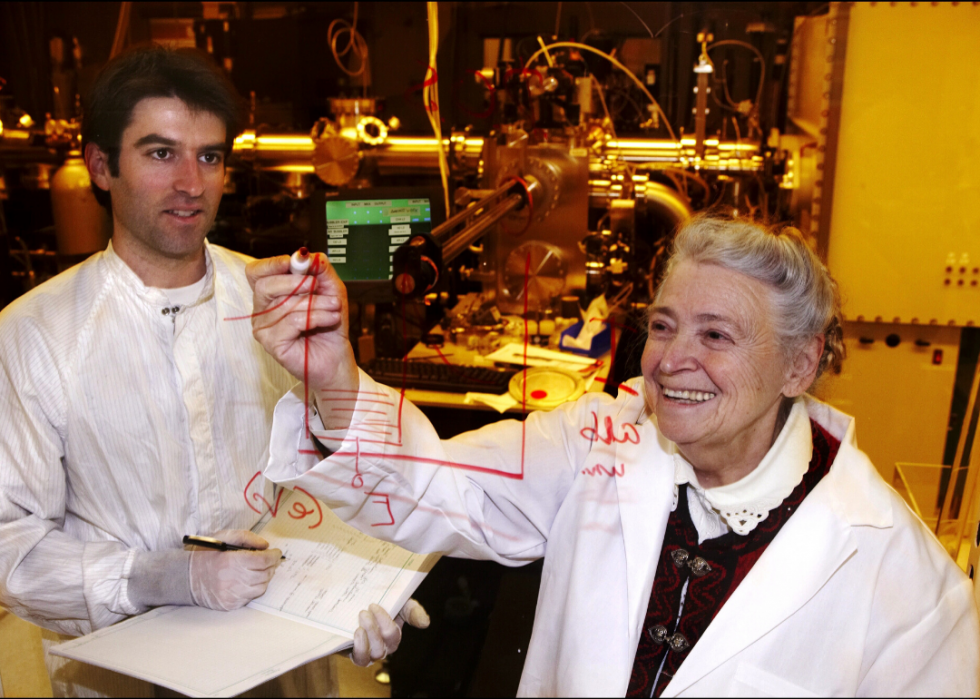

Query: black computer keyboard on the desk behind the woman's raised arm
361,357,519,395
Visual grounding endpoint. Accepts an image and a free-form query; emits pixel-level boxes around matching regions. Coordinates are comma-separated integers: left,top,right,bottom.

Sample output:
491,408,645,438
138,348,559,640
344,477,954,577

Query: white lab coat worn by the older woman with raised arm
266,373,980,696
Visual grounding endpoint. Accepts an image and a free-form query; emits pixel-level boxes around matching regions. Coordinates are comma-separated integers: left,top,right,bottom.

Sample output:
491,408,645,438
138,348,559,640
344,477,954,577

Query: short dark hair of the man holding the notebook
82,46,244,211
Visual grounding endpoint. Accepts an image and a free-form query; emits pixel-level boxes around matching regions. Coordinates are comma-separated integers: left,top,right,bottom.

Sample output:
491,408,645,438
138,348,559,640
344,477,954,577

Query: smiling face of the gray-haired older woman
643,261,789,468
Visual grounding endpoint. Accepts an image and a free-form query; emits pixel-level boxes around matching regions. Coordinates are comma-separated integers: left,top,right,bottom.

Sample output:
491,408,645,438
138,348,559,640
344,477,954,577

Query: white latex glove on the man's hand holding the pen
190,529,282,611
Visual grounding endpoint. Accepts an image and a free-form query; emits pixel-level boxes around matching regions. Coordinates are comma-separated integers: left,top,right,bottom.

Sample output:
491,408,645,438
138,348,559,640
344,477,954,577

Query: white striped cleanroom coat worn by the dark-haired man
0,245,334,694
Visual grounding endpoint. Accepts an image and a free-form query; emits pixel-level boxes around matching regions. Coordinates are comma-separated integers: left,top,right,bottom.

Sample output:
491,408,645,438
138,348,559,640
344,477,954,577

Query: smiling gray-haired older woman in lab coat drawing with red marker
251,218,980,696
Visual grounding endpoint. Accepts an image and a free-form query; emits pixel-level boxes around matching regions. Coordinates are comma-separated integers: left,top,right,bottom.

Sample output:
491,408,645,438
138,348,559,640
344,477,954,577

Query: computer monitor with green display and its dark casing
310,187,445,303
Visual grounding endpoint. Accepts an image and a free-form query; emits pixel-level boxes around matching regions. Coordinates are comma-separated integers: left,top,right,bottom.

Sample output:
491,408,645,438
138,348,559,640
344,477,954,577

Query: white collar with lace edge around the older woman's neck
674,397,813,538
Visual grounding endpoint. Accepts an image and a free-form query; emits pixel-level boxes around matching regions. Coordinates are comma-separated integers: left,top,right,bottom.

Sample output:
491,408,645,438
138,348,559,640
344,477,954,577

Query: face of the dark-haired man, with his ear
97,97,225,260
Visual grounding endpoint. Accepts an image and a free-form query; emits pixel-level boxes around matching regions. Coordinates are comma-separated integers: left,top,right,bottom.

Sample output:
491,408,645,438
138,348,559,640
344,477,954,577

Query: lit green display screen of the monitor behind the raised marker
326,199,432,282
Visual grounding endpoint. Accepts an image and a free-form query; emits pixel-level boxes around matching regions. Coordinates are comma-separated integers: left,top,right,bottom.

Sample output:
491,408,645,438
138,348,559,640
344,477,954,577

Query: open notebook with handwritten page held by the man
51,492,438,697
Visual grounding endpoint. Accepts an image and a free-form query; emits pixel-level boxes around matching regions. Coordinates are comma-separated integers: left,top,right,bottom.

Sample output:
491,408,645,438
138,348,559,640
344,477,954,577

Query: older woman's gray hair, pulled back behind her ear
656,214,844,377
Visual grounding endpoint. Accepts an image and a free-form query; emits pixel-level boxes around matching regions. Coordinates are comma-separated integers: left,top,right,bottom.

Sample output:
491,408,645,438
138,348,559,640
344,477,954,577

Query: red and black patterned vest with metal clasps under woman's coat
626,420,840,697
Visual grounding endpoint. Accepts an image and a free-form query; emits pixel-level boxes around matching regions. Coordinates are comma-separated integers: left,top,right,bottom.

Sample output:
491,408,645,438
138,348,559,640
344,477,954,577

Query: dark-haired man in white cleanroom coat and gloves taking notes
0,49,428,694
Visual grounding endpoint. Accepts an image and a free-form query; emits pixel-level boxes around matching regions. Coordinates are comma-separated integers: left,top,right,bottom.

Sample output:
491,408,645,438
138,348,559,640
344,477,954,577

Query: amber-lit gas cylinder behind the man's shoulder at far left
51,150,112,261
